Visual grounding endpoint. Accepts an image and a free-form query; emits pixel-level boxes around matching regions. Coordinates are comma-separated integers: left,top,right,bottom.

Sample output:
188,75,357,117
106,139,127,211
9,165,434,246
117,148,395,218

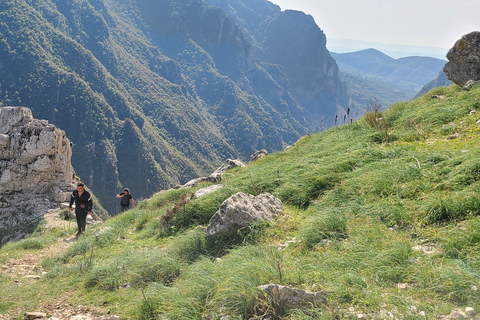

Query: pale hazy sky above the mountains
270,0,480,49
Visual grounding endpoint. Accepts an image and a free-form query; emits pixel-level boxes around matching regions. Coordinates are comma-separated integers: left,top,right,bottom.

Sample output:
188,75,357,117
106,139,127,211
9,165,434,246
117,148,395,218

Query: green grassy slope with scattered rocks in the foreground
0,86,480,319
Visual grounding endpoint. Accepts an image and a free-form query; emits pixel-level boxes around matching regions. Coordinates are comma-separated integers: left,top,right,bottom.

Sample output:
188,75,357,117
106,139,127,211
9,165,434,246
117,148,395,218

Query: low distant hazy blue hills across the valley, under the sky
331,49,446,108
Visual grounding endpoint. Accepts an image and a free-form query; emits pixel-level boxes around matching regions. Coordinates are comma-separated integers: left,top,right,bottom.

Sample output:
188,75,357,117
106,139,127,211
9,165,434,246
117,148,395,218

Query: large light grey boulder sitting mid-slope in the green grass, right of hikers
207,192,282,235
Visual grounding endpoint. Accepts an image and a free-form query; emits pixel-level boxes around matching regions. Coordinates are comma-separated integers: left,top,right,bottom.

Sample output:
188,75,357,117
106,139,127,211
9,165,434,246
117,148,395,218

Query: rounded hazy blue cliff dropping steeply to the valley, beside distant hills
260,10,351,127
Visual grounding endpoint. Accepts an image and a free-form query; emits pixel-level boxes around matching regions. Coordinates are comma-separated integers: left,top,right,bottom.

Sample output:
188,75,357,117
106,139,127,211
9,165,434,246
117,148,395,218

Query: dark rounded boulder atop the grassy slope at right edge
443,31,480,88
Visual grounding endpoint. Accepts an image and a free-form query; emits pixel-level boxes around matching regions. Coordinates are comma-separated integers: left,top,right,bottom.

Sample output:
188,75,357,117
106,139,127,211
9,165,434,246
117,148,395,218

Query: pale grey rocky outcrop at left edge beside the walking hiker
0,107,75,244
